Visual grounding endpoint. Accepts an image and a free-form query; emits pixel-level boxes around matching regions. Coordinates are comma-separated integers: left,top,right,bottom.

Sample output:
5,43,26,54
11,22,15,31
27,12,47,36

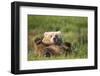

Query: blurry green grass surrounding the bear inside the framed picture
28,15,88,60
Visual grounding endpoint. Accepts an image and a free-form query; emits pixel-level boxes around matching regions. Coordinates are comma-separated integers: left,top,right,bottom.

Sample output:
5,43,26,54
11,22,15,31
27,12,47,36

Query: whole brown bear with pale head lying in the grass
34,31,71,57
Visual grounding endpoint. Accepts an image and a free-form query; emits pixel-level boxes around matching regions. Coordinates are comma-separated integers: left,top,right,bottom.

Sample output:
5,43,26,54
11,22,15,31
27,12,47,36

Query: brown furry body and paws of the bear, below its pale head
34,38,71,57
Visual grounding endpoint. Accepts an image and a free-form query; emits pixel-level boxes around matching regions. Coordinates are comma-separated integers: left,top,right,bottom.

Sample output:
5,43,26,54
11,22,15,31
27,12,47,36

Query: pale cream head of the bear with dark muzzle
42,31,62,45
